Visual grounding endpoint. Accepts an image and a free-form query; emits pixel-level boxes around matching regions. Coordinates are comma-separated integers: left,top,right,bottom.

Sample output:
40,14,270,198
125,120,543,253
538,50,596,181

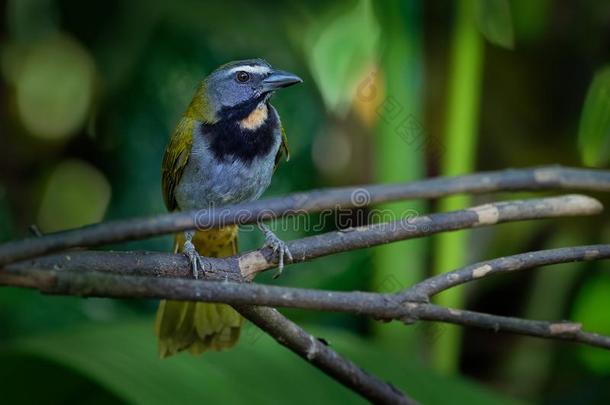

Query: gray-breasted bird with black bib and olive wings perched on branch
155,58,303,358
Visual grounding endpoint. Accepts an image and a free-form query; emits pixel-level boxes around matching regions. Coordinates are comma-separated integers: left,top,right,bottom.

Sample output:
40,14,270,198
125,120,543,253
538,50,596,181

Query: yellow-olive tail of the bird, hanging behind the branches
156,225,243,358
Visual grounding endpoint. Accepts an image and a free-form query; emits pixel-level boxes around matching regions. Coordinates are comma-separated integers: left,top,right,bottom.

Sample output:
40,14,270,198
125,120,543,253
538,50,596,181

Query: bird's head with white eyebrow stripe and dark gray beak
187,59,303,123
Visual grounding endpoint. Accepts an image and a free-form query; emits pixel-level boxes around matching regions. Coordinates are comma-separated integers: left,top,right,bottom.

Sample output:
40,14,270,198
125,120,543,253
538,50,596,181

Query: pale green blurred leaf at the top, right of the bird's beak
305,0,380,114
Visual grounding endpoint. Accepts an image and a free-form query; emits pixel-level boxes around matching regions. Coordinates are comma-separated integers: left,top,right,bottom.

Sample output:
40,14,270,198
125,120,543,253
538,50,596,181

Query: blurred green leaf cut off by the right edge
578,66,610,167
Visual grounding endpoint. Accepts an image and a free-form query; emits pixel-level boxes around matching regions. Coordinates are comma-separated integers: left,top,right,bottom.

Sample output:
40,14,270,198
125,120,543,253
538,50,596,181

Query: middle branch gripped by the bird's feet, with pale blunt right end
9,196,601,281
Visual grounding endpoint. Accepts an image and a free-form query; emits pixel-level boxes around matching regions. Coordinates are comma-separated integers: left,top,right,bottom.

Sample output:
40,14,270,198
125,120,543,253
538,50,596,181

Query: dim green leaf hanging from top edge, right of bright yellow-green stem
475,0,514,49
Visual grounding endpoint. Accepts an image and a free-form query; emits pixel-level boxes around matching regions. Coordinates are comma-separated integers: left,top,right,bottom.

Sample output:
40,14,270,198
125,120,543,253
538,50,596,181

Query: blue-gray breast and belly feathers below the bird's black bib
175,120,281,210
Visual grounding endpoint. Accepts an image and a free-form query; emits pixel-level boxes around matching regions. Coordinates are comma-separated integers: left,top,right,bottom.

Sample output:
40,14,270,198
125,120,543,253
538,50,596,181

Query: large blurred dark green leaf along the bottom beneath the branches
0,320,513,405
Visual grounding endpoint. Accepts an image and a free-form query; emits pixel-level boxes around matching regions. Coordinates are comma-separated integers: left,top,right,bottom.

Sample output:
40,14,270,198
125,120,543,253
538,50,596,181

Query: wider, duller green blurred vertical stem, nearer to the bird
373,0,425,354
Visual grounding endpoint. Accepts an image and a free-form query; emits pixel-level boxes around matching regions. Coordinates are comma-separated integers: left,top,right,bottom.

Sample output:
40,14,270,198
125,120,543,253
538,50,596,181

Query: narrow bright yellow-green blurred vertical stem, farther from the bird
431,0,484,373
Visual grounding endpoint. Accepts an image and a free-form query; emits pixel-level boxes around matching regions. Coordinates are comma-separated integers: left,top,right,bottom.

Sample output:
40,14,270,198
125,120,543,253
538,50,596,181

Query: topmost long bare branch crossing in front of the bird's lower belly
0,166,610,266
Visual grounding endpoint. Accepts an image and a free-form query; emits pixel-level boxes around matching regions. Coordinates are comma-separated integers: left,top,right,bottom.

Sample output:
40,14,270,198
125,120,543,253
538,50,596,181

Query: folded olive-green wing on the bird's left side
161,117,194,211
